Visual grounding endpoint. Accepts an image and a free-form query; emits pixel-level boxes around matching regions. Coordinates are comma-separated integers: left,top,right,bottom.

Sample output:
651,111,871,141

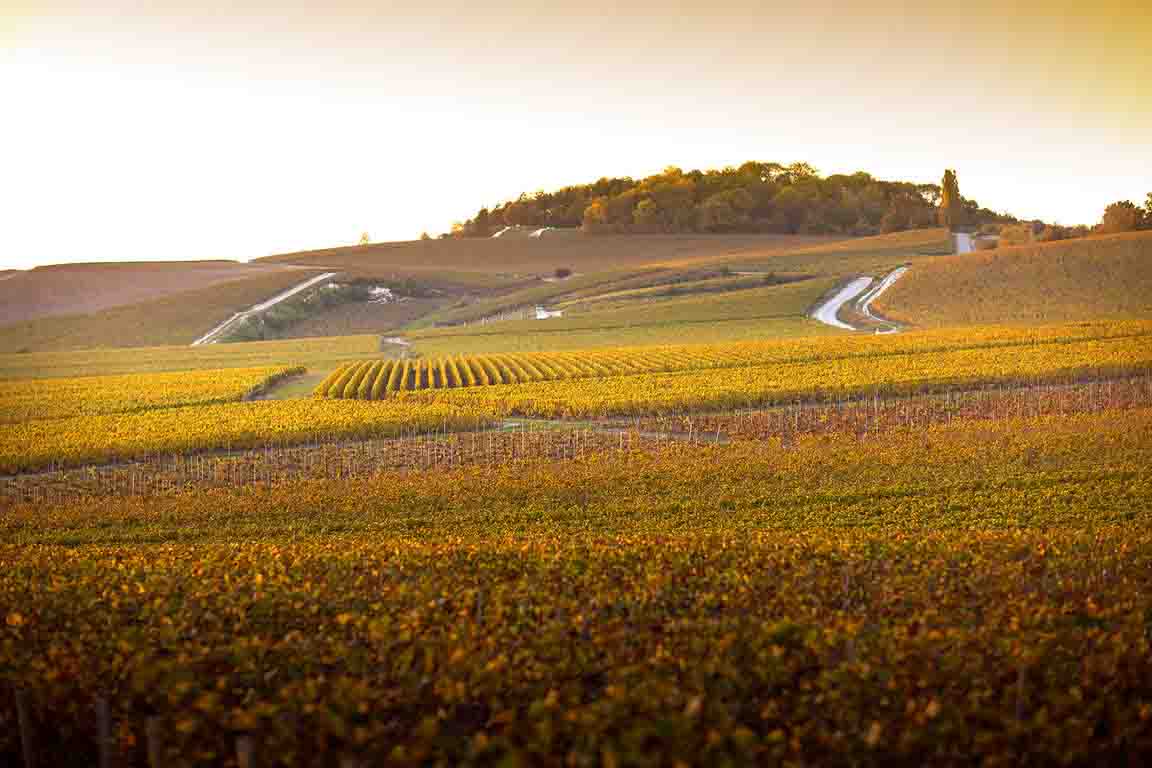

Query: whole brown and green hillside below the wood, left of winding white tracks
0,229,947,352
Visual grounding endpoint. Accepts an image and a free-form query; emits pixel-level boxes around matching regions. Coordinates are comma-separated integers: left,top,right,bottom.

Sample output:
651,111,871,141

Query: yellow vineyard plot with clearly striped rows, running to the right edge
314,322,1152,400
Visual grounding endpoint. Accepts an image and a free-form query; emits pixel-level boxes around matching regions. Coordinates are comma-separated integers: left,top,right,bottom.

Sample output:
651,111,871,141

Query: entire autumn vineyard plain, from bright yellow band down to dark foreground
0,299,1152,768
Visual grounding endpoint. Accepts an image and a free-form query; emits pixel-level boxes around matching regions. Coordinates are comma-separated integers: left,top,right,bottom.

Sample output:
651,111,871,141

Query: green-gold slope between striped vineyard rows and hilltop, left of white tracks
404,229,947,355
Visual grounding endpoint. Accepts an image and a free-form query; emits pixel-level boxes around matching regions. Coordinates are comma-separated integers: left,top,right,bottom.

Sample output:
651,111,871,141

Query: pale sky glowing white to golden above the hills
0,0,1152,268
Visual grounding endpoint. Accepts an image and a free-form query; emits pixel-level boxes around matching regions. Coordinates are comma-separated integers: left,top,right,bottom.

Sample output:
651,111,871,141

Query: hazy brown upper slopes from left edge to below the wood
0,235,857,352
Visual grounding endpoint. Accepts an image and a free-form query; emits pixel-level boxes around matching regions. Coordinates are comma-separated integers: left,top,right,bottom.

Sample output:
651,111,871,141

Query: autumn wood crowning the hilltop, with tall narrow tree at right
452,162,1016,237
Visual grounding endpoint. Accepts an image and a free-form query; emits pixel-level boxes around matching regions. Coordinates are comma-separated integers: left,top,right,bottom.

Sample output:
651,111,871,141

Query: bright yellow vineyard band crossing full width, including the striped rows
0,321,1152,473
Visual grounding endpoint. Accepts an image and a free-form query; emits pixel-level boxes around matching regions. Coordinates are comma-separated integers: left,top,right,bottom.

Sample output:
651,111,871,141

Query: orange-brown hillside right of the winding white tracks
877,231,1152,326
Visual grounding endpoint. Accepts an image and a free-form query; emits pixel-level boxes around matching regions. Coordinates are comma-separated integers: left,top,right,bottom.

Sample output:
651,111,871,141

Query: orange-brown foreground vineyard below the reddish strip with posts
0,408,1152,766
